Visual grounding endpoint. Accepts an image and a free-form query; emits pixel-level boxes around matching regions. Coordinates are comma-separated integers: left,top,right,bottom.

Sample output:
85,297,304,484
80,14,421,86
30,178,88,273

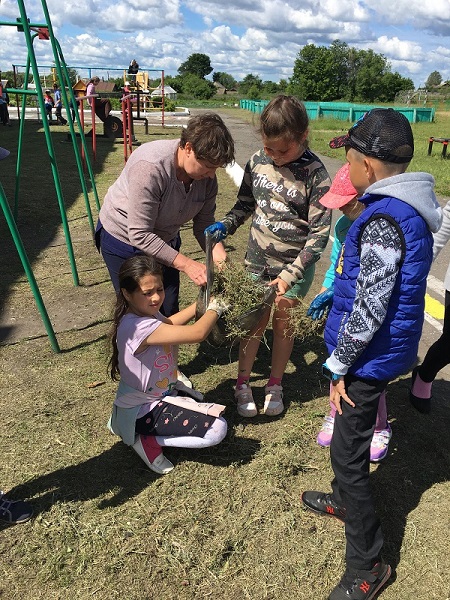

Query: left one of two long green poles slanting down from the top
17,0,80,285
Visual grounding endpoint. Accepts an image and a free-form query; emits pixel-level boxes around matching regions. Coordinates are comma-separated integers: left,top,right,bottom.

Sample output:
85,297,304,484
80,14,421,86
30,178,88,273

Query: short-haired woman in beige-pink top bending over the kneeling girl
96,113,234,317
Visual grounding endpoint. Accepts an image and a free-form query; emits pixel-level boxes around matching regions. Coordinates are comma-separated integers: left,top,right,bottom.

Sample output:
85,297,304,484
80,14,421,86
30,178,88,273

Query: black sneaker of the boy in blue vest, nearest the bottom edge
328,561,391,600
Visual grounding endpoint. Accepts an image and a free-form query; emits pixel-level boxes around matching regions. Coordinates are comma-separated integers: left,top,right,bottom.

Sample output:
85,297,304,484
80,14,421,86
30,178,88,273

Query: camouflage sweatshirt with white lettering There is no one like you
222,150,331,287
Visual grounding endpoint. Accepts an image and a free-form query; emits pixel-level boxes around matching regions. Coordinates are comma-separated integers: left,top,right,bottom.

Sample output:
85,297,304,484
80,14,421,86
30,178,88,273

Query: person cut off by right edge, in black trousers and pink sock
409,201,450,414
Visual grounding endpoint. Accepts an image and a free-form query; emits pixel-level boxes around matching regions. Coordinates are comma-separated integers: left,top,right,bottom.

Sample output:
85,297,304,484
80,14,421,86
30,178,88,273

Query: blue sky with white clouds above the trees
0,0,450,87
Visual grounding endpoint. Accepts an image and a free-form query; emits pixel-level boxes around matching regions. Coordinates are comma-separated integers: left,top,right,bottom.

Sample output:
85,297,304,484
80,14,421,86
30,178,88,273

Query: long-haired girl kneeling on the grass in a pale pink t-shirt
109,255,227,474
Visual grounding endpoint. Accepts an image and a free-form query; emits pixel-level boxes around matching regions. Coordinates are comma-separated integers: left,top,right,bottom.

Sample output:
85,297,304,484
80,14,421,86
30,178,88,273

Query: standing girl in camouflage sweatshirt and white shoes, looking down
206,95,331,417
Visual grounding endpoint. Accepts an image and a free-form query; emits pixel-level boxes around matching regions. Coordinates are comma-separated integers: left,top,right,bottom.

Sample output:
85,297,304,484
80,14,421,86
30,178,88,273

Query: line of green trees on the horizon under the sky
165,40,414,102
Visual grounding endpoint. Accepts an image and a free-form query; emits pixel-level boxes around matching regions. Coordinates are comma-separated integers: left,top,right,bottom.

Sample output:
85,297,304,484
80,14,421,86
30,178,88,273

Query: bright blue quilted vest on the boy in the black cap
324,194,433,380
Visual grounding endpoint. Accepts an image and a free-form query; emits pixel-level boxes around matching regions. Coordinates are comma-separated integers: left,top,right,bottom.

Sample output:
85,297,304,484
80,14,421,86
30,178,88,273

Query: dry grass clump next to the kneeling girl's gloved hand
211,262,267,340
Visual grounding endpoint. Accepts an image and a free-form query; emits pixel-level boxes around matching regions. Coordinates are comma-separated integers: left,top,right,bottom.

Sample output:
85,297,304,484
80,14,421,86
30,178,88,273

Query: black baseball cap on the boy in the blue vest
329,108,414,164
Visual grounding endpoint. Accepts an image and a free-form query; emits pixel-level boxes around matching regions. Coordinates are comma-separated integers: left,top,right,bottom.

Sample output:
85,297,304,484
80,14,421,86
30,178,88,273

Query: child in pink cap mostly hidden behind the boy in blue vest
307,163,392,462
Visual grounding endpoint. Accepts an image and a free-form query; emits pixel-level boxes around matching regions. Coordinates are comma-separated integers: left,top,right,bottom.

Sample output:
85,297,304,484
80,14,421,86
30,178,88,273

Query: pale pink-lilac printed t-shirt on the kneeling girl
117,313,178,399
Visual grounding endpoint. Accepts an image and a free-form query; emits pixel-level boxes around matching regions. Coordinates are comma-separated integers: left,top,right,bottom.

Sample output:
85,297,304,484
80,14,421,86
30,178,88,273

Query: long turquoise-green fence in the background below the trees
240,100,435,123
